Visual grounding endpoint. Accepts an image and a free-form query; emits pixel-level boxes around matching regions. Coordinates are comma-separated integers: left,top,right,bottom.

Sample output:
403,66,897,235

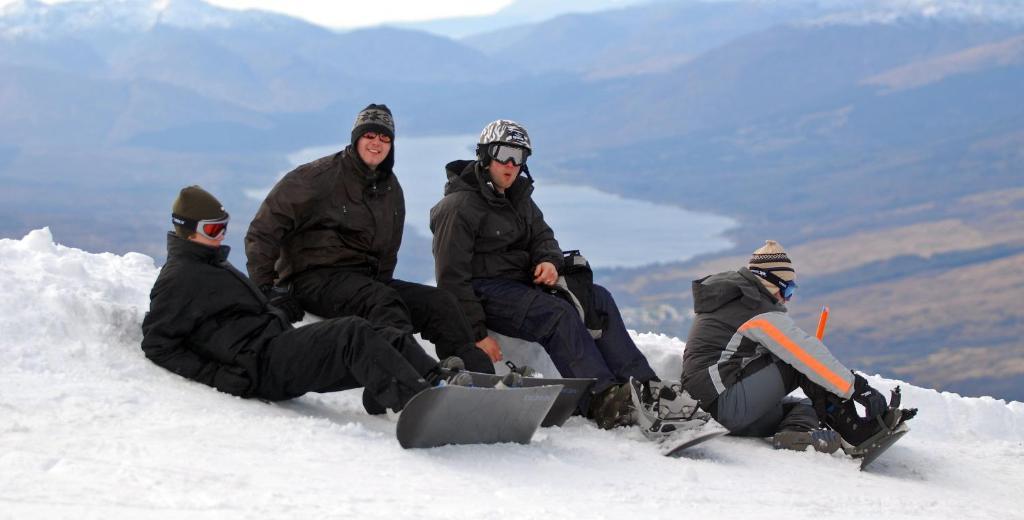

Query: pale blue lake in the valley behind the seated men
256,135,736,268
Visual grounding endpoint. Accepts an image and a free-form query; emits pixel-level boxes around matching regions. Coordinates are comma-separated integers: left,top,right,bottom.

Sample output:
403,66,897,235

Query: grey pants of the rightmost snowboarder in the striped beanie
711,360,818,437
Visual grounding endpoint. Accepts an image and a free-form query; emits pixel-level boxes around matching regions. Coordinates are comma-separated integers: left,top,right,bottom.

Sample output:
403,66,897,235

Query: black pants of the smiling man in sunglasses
292,269,495,374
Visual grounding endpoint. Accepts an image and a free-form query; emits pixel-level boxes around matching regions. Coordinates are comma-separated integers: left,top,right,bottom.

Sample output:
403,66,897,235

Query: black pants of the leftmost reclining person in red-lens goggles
254,317,437,409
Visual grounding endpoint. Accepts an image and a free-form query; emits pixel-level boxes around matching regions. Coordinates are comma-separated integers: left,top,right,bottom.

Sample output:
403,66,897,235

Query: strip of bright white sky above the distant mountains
0,0,512,28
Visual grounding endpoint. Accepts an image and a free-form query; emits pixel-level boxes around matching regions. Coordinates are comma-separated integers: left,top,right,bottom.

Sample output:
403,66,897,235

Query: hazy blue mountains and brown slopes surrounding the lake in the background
0,0,1024,399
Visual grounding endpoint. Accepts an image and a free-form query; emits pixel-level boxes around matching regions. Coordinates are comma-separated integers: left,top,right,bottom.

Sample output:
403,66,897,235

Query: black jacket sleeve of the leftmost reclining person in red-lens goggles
142,279,251,396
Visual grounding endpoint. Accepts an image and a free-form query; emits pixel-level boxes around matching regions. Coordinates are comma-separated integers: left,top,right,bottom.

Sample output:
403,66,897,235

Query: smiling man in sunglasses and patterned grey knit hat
245,103,495,409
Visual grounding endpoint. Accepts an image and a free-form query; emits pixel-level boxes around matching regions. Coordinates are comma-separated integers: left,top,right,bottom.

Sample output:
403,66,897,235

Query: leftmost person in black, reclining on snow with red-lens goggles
142,186,439,410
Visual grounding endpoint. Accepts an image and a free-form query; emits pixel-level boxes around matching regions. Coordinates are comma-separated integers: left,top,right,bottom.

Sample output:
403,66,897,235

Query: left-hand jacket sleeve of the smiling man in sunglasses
245,170,317,287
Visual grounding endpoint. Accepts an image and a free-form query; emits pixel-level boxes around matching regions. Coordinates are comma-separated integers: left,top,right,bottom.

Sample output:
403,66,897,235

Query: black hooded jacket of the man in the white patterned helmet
430,161,562,341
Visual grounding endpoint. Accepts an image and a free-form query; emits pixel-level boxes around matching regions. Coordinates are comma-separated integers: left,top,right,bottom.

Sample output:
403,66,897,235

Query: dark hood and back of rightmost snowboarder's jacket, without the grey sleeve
682,267,785,406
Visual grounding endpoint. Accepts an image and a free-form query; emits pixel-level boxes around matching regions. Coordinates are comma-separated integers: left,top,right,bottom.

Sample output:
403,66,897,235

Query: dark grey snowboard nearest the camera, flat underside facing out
395,385,562,449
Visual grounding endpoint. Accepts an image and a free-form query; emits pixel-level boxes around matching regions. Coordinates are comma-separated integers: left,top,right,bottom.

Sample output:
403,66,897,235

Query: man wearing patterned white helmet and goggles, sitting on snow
430,120,656,428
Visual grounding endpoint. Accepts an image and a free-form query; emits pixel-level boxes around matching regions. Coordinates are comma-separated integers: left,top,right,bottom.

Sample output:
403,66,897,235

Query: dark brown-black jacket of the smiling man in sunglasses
246,145,406,286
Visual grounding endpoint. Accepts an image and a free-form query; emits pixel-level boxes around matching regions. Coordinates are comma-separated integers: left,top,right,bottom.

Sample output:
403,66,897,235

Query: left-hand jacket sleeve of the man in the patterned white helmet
430,200,487,341
